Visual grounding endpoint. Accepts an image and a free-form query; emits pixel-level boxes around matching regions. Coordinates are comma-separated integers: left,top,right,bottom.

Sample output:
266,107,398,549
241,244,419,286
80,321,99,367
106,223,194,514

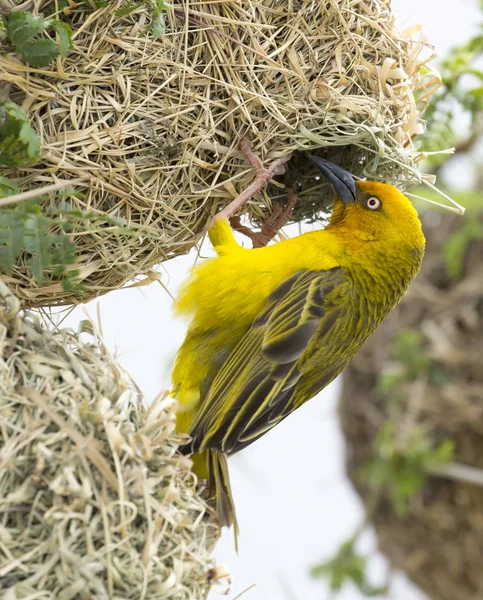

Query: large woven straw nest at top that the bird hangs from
0,0,435,306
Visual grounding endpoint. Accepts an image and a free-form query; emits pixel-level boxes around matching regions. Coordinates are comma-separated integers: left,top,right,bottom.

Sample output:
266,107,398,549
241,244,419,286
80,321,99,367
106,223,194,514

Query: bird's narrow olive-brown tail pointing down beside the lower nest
191,449,238,549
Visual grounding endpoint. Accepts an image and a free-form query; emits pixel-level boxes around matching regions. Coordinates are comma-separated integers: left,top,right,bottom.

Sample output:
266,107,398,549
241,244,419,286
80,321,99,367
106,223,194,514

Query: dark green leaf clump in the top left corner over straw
6,10,72,67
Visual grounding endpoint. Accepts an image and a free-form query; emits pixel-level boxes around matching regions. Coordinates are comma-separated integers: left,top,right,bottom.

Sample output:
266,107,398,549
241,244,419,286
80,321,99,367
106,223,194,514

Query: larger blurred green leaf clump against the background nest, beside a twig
361,421,454,517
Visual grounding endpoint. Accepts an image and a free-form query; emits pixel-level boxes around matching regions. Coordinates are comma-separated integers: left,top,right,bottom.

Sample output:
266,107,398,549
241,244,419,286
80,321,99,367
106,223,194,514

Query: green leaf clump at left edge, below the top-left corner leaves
0,100,40,167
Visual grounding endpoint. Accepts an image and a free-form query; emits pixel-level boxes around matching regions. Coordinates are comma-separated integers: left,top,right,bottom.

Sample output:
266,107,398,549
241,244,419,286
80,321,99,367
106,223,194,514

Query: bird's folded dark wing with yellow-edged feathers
189,267,352,454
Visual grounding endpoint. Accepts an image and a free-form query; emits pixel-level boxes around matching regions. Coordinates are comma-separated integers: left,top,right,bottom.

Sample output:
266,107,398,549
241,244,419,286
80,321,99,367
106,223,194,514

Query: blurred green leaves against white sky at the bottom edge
310,538,387,597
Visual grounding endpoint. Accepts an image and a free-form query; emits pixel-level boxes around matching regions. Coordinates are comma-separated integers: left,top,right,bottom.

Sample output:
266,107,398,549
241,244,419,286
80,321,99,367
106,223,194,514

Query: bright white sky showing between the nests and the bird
59,0,479,600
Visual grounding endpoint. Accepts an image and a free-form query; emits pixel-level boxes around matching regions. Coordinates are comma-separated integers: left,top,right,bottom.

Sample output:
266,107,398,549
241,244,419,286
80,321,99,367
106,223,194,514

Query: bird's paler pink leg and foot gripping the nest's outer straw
210,138,292,227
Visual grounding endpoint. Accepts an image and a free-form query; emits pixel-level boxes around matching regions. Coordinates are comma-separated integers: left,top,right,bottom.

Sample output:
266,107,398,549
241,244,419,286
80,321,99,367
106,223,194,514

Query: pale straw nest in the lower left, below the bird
0,282,219,600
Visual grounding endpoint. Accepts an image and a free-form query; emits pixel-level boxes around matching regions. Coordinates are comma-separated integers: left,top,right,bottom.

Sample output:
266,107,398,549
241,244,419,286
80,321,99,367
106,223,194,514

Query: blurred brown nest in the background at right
340,213,483,600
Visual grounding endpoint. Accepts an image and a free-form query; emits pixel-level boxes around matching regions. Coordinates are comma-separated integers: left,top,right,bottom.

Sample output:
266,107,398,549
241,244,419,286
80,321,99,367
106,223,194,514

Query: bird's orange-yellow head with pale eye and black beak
310,156,425,250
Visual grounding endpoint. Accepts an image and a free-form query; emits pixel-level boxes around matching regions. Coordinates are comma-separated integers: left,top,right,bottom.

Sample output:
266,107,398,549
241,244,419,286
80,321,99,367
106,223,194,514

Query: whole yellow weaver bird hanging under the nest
171,157,425,534
